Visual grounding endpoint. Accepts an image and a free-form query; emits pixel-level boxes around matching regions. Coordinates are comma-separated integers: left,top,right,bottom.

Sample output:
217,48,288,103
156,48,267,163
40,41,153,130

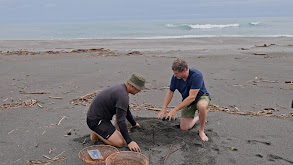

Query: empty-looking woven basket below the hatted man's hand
106,151,149,165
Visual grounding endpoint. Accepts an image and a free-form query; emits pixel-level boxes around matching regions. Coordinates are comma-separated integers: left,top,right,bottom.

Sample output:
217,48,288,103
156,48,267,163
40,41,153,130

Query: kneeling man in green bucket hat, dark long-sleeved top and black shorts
87,73,146,152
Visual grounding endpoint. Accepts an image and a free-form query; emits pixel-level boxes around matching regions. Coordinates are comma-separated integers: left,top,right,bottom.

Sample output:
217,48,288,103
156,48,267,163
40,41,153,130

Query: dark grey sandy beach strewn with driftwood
0,37,293,165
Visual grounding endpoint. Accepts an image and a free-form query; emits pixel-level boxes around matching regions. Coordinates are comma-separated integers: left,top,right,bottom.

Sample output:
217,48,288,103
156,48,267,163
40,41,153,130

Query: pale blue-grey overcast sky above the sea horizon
0,0,293,24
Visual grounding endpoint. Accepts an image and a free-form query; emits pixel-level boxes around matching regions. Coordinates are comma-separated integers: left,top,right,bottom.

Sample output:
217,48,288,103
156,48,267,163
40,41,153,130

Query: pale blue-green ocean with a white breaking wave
0,17,293,40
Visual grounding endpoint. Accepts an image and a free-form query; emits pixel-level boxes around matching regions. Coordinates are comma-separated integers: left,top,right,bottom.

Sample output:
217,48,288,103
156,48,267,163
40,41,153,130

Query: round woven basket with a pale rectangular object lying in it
78,145,119,164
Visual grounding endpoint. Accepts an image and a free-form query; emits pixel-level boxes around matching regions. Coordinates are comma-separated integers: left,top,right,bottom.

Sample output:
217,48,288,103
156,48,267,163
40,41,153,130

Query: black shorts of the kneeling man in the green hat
86,119,116,140
